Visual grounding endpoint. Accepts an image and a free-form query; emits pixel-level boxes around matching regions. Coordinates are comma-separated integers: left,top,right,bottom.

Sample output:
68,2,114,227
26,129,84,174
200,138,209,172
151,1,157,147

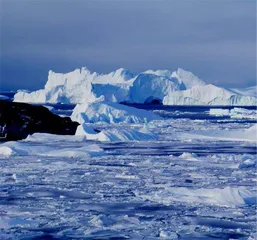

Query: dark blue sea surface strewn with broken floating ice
0,106,257,240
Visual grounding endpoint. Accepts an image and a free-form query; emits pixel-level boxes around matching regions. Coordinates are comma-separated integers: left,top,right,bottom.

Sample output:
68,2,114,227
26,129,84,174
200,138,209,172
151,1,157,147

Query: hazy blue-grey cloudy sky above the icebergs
0,0,256,91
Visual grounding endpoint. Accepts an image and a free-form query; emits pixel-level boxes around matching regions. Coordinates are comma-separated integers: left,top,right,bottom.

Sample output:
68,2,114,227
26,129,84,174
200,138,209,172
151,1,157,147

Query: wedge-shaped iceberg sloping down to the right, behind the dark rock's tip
71,102,161,123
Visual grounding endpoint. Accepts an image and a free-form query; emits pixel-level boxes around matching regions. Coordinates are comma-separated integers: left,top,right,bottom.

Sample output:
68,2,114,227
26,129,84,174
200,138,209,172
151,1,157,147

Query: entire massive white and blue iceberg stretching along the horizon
14,67,257,106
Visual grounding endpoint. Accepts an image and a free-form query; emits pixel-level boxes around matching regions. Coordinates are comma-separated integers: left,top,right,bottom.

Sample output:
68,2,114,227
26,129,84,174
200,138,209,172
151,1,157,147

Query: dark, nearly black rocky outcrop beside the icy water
0,100,79,141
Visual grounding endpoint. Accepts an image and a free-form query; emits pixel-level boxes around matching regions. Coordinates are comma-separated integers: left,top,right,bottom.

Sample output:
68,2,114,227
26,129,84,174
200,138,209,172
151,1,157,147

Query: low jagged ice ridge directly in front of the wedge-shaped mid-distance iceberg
76,124,158,142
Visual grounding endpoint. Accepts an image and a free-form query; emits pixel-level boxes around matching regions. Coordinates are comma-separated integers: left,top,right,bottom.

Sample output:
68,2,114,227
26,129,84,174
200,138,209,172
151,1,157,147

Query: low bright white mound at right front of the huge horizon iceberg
163,84,257,106
